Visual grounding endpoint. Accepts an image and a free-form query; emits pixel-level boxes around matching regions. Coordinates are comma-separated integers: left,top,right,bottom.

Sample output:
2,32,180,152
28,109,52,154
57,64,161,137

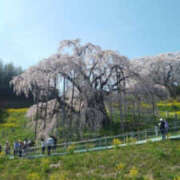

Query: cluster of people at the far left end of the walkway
0,139,34,157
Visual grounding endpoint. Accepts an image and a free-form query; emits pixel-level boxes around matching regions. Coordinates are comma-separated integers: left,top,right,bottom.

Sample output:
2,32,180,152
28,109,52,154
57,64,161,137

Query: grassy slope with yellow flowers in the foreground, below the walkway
0,140,180,180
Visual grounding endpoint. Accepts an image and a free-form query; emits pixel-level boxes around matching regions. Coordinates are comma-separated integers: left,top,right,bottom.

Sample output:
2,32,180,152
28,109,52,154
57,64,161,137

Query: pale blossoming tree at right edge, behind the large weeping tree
134,53,180,97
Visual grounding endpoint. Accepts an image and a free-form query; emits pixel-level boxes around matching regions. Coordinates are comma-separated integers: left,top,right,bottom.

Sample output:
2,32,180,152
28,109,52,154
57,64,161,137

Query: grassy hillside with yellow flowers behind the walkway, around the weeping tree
0,101,180,143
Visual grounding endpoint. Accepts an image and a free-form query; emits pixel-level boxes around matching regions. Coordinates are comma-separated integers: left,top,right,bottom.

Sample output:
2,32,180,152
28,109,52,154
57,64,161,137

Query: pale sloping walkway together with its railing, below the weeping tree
9,121,180,159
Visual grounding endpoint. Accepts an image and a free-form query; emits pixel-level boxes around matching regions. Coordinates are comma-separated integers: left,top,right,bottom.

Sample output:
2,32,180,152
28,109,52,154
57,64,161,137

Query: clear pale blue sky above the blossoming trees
0,0,180,68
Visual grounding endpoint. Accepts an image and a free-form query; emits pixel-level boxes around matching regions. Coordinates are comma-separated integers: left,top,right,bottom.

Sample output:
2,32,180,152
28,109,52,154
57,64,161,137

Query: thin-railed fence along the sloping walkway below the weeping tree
24,121,180,157
